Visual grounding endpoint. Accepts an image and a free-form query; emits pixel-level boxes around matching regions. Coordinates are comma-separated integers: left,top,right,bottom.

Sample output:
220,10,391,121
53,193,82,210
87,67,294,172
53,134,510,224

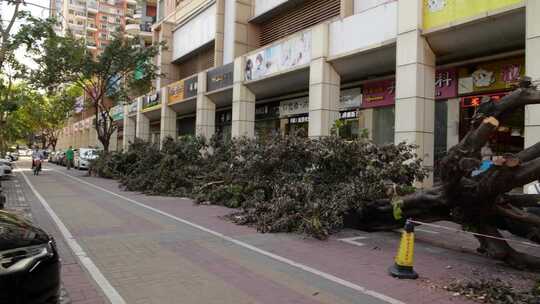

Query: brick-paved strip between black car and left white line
2,172,108,304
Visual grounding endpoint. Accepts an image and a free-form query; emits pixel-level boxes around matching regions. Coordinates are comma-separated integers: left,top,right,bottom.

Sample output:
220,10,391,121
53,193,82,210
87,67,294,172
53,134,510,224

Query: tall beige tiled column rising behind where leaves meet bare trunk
395,0,435,187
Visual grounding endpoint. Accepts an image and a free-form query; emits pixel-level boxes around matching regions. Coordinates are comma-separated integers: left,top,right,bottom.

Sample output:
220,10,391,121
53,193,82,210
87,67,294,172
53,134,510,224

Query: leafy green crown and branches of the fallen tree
92,136,426,239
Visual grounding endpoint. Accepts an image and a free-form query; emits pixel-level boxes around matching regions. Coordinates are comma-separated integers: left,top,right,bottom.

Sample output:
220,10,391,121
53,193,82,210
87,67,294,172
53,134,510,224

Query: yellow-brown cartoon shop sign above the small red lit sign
458,57,525,94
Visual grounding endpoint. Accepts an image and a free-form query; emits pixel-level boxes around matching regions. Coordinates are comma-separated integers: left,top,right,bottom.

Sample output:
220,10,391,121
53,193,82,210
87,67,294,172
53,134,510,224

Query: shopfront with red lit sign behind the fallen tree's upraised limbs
458,57,525,157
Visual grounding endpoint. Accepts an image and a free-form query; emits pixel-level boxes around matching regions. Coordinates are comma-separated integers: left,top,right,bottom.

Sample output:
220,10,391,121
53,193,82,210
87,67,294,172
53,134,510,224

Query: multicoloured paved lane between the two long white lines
16,159,399,304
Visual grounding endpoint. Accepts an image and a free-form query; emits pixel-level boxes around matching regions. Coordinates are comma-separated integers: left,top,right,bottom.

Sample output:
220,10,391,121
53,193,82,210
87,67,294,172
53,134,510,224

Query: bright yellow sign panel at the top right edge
423,0,523,30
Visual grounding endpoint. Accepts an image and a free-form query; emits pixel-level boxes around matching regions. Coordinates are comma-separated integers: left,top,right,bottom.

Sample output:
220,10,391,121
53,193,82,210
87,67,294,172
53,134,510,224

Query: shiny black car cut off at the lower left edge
0,210,60,304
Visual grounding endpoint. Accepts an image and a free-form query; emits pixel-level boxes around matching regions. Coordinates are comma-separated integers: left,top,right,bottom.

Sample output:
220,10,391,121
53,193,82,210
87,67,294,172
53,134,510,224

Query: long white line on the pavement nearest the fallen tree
53,169,405,304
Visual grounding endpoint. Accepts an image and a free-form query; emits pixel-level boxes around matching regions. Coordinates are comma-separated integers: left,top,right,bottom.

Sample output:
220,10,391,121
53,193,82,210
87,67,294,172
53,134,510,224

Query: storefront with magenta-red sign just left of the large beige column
361,78,396,145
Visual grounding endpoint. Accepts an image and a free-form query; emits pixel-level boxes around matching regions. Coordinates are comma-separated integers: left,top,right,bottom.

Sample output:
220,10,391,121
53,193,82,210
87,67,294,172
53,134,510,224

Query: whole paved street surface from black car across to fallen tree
15,161,536,304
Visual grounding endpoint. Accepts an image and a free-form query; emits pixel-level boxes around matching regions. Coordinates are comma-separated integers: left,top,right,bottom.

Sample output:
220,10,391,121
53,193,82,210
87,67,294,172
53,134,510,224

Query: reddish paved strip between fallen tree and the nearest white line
57,168,540,304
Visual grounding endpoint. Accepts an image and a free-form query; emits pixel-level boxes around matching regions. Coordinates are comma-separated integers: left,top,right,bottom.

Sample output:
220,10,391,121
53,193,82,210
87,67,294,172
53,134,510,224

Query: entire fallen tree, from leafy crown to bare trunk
92,80,540,271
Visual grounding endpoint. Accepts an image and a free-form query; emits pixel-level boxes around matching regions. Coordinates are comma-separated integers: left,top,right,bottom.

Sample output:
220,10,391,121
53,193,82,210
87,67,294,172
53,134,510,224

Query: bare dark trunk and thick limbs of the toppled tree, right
355,79,540,271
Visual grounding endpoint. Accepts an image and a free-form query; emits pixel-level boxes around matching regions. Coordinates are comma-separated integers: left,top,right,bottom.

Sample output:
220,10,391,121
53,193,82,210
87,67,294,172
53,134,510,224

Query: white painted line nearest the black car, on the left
21,171,126,304
